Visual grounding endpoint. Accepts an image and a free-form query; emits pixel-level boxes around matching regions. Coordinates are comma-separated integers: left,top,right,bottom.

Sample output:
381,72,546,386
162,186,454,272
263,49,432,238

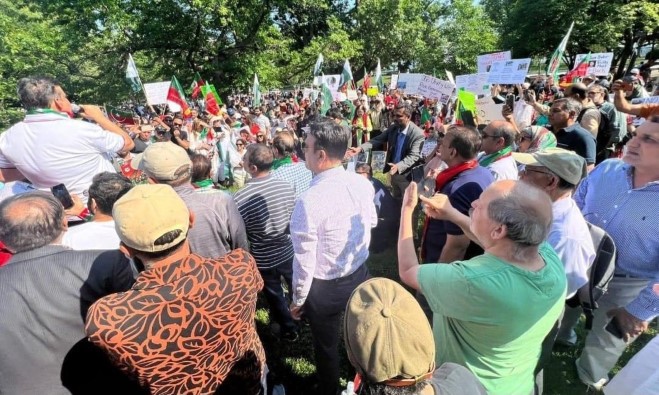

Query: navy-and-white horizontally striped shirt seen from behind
234,175,295,269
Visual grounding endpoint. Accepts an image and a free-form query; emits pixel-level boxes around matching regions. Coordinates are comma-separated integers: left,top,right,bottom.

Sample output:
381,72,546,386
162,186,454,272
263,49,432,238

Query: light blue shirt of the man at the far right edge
574,159,659,321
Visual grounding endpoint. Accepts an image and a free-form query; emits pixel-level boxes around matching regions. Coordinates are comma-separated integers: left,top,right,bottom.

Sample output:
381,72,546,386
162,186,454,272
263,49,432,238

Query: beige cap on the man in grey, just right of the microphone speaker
133,141,192,181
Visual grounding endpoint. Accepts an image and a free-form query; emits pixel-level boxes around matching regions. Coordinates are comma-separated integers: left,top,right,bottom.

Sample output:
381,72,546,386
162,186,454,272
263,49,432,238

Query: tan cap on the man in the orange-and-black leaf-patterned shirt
112,184,190,252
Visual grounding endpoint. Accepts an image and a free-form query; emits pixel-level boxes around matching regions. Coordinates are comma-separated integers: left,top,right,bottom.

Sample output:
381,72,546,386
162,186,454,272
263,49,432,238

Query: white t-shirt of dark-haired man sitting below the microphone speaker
62,221,121,250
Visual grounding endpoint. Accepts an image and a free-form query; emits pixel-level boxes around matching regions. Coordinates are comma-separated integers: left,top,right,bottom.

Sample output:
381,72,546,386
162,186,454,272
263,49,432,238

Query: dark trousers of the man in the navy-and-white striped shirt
259,257,297,334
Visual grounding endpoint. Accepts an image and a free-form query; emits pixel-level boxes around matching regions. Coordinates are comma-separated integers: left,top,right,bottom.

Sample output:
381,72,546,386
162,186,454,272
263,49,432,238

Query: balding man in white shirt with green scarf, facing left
478,121,517,181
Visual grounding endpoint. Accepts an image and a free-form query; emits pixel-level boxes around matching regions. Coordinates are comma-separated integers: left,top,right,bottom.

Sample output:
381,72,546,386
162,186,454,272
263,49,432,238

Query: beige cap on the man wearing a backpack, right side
513,148,588,185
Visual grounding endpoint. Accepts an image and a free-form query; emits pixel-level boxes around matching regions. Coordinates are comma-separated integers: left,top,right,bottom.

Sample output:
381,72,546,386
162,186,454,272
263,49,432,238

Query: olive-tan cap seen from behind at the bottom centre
344,278,435,386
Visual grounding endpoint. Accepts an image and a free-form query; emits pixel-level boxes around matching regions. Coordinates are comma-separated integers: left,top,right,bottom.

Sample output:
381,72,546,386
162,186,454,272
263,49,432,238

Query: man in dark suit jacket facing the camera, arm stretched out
350,104,424,199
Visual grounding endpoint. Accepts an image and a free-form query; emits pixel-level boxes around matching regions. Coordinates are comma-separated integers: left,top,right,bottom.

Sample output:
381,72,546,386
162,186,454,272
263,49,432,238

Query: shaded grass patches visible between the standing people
250,175,659,395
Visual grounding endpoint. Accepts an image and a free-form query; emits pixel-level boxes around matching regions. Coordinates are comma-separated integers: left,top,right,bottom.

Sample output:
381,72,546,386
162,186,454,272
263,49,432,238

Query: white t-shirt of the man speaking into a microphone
0,112,124,202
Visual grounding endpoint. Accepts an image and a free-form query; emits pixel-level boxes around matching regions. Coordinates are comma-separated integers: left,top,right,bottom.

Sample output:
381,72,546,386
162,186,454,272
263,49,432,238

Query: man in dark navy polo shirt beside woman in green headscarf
549,99,596,171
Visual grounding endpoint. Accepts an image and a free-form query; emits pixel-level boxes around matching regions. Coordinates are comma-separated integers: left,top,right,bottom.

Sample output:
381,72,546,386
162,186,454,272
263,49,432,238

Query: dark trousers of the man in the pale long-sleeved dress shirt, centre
304,265,369,395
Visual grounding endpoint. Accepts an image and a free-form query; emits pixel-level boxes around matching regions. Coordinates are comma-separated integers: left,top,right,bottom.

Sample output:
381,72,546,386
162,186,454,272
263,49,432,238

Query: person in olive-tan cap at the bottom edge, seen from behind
344,278,487,395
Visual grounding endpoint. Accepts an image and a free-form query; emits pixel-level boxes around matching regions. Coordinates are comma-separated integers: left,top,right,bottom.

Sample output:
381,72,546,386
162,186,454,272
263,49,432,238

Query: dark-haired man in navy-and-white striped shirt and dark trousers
234,144,298,341
